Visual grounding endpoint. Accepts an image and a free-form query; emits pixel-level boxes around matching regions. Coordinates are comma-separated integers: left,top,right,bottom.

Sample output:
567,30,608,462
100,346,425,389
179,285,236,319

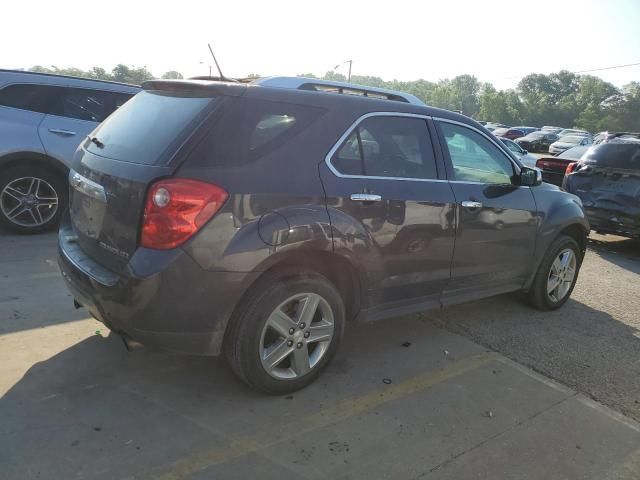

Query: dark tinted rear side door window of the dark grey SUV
331,116,437,178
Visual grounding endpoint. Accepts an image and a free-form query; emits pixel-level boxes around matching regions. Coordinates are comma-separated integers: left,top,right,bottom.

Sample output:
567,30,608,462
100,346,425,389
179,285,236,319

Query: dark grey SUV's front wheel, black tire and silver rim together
529,235,582,310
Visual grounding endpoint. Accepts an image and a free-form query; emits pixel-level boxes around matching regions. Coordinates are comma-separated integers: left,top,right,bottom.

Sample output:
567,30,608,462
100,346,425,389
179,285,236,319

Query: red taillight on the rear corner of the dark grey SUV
141,178,228,250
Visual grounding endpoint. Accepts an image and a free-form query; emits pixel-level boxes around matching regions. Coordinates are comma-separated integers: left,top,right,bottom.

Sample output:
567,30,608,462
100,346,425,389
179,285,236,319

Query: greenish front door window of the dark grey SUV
440,122,514,184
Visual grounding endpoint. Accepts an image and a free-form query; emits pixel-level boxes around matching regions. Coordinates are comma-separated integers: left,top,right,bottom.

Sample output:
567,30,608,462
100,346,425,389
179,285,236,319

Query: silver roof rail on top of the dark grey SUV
251,77,425,106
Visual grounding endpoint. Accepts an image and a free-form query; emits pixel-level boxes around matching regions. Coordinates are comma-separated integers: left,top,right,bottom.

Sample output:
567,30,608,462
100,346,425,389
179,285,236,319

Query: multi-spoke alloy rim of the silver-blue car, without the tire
0,177,58,227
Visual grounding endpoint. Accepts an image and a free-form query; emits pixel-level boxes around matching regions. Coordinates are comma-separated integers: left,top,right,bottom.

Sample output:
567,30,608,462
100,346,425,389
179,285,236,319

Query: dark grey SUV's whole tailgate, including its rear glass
69,84,242,273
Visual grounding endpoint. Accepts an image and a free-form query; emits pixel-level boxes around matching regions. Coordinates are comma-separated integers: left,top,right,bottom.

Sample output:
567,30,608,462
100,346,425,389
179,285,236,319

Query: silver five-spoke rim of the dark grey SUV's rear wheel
260,293,334,380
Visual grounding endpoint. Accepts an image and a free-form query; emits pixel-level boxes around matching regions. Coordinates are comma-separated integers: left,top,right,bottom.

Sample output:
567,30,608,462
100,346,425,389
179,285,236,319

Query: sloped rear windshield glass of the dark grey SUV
87,91,215,165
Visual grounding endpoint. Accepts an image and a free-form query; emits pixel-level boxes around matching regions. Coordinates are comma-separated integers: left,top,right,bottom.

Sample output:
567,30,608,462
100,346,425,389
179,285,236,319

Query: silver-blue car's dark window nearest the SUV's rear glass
50,87,131,123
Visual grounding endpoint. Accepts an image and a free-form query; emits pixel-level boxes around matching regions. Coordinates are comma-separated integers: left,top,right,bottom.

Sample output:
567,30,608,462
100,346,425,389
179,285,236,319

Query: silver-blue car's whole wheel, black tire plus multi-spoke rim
0,165,68,234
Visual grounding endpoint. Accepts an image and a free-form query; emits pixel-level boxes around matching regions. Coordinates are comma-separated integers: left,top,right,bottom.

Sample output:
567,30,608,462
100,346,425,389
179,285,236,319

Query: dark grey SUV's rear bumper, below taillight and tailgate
58,222,258,355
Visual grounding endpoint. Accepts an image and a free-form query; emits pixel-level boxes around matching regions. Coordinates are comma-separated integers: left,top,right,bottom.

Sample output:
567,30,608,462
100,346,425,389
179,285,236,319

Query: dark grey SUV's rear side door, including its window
320,113,455,316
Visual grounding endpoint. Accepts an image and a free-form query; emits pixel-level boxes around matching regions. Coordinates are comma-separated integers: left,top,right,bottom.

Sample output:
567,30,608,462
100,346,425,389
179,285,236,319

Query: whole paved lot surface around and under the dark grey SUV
0,232,640,480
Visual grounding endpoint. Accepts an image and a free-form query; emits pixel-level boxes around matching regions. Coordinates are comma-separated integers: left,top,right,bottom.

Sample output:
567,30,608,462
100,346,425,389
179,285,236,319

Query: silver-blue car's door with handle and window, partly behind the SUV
38,87,131,165
